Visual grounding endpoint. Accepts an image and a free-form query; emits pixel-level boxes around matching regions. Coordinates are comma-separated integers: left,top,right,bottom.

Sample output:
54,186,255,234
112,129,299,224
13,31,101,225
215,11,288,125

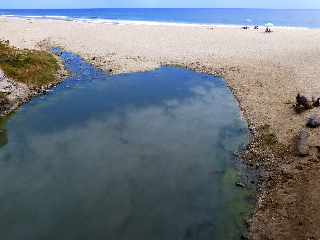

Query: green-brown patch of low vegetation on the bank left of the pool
0,41,60,88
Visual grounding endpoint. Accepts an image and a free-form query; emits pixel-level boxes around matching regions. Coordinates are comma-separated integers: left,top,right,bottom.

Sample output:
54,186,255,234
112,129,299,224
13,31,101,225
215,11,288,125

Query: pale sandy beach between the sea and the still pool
0,17,320,239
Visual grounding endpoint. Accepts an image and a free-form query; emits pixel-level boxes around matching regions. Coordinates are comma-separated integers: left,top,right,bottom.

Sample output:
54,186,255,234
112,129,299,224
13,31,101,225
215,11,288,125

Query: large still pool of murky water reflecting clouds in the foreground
0,53,251,240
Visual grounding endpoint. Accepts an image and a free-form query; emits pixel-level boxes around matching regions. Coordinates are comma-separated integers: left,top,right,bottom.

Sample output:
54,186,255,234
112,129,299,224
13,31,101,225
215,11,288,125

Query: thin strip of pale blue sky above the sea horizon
0,0,320,9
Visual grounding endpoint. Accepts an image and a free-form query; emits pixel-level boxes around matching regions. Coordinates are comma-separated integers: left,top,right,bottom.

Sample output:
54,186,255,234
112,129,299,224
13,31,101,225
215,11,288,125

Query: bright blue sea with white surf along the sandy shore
0,8,320,28
